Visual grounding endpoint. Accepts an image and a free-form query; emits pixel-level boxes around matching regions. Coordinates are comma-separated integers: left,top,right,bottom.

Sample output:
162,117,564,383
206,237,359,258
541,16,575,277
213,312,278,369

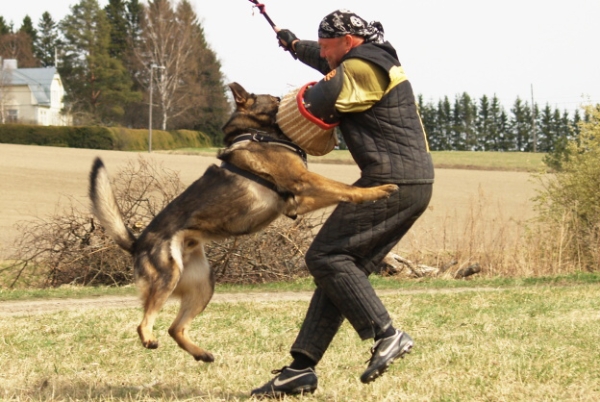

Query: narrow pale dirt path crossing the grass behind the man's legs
0,288,502,317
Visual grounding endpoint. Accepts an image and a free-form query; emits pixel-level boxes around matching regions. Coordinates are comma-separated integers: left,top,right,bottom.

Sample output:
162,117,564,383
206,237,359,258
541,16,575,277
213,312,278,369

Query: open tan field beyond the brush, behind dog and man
0,144,541,258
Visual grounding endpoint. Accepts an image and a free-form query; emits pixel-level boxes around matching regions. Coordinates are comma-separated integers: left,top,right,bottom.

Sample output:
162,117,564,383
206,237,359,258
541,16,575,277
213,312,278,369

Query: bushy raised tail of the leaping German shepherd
89,158,135,253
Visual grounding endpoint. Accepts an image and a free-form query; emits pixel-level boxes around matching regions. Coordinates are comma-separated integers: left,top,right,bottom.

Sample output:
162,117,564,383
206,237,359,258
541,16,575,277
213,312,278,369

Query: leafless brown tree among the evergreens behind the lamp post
134,0,204,130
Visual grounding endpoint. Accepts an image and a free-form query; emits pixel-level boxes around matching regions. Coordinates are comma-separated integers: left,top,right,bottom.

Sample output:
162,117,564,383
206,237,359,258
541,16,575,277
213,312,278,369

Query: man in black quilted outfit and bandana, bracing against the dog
252,9,434,397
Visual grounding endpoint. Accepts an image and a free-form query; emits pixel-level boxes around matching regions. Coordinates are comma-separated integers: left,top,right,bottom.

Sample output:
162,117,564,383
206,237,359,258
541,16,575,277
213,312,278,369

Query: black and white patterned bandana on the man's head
319,9,384,43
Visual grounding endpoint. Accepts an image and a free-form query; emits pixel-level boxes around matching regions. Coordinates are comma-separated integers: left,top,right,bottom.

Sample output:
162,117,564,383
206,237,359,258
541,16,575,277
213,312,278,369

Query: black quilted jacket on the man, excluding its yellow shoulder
296,41,434,184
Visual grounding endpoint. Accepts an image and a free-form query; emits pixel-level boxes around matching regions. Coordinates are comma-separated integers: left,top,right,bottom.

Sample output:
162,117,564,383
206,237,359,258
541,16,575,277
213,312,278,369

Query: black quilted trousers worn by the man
291,179,433,362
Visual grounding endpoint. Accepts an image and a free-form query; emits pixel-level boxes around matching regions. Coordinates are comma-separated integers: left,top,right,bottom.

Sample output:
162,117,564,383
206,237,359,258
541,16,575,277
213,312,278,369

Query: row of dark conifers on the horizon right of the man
418,93,589,153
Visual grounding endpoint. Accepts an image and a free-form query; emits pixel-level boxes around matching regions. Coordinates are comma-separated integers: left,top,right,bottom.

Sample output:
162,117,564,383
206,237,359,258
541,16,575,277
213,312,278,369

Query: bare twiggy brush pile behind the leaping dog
2,156,319,287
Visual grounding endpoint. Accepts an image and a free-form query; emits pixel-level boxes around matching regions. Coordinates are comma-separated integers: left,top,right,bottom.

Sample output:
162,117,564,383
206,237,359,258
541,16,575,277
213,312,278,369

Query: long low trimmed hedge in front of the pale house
0,124,212,151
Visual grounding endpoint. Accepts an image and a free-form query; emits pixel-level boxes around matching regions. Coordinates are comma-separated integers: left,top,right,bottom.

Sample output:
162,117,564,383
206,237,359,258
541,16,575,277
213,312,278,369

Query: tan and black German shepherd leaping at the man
89,82,397,362
